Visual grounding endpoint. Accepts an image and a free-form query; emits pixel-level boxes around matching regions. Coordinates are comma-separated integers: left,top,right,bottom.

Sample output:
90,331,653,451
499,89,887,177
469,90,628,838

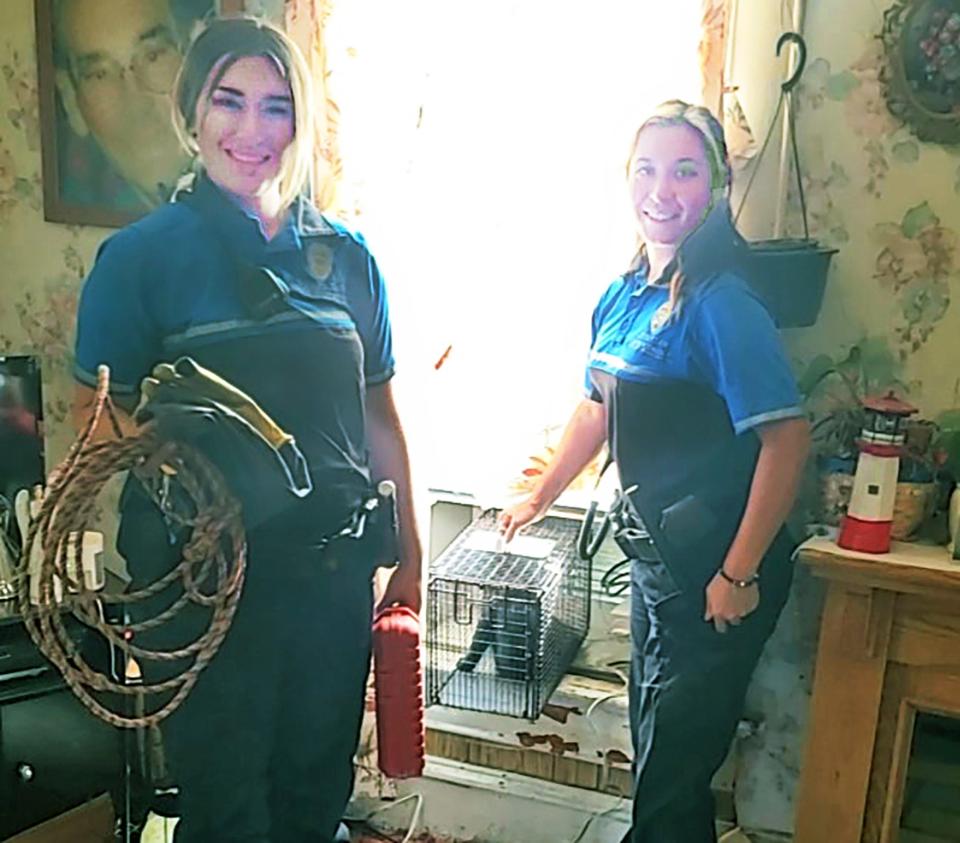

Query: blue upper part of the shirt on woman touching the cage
586,271,803,434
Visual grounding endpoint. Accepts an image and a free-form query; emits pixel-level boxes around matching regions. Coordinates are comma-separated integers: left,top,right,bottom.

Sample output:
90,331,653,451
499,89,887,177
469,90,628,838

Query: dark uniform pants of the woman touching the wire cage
624,560,790,843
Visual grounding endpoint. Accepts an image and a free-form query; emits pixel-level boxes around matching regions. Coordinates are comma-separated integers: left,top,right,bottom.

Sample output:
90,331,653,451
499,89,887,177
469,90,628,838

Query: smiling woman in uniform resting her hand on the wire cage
500,101,809,843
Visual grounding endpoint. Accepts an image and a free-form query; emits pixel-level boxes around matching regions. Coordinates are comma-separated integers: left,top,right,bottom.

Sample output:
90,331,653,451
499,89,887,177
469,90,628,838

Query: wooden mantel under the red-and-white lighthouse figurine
794,538,960,843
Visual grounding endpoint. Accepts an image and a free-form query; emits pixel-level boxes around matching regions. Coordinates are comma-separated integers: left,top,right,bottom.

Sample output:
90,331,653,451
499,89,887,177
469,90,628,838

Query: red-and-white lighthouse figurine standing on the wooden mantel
837,392,917,553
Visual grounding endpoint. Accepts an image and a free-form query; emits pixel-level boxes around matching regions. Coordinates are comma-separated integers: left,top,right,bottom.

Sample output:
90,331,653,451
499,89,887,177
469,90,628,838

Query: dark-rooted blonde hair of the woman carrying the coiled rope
173,16,317,213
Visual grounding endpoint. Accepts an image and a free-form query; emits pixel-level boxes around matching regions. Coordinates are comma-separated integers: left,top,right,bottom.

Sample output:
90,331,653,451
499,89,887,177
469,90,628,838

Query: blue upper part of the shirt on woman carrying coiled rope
74,176,394,394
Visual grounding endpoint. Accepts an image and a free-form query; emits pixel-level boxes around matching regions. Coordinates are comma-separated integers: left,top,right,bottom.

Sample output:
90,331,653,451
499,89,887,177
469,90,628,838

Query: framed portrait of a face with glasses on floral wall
34,0,243,227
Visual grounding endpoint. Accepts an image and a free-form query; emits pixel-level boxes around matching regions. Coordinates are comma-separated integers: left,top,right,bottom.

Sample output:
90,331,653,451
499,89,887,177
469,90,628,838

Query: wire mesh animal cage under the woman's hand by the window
426,511,590,720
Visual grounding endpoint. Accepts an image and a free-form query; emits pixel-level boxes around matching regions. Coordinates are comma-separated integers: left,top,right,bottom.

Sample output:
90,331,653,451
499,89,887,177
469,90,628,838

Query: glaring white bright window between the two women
328,0,701,493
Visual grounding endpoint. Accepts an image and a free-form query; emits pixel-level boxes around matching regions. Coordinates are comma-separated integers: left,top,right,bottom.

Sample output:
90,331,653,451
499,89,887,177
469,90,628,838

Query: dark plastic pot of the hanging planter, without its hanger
741,239,837,328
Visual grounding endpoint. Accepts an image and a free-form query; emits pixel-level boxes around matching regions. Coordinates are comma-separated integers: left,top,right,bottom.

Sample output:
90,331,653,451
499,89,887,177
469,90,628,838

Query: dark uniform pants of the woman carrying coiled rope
135,542,373,843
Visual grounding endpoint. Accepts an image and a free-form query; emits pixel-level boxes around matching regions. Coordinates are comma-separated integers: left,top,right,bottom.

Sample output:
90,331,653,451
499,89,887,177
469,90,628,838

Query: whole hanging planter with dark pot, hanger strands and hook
736,32,837,328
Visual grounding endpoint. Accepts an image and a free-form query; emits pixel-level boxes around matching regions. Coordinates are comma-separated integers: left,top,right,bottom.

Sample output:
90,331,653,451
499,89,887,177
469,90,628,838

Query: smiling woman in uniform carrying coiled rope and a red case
76,18,421,843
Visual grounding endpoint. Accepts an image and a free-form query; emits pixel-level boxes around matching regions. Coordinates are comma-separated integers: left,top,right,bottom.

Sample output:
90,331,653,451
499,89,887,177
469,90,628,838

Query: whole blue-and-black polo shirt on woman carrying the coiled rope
75,176,393,531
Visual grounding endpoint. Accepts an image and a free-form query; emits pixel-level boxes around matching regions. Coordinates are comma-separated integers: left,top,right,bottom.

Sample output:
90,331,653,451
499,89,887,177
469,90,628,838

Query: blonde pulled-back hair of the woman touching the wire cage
627,100,732,314
